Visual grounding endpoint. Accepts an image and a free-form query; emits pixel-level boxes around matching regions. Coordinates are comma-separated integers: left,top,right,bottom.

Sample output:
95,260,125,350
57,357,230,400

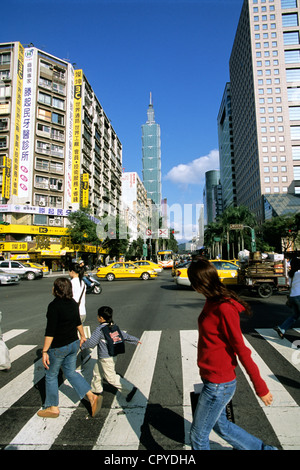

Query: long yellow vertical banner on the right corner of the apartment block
72,70,82,204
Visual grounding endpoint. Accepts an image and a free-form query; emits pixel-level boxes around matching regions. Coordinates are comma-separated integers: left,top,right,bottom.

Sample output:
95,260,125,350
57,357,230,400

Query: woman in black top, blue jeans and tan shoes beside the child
37,277,102,418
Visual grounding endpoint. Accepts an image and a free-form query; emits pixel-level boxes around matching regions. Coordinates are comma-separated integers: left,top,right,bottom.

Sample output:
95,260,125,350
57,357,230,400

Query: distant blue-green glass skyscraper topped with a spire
142,93,161,212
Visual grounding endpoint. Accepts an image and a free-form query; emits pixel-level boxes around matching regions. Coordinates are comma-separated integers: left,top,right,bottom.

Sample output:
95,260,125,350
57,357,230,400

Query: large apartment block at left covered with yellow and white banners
0,42,122,260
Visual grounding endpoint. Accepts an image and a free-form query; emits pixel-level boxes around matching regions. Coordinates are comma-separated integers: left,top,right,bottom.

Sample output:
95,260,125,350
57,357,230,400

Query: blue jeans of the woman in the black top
43,340,91,408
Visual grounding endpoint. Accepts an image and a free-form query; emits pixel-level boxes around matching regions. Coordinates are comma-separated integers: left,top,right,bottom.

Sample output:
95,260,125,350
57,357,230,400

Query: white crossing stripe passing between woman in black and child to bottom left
5,348,97,450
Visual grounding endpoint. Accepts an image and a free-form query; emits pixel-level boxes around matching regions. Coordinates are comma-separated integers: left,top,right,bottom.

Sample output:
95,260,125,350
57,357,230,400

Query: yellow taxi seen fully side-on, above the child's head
97,261,157,281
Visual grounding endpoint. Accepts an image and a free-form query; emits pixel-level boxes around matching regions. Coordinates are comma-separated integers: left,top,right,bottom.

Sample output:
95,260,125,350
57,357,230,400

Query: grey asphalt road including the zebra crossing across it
0,271,300,452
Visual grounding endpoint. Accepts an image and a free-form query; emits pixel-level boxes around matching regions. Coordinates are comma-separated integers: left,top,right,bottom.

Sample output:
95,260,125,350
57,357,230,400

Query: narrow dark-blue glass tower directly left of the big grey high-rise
217,83,236,209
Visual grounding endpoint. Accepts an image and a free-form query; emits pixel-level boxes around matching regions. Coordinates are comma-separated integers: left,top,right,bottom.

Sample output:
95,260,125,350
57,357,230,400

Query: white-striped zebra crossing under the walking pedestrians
0,329,300,450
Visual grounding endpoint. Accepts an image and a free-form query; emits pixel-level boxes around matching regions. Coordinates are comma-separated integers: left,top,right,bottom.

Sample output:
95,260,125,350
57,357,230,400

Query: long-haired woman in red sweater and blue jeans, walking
188,258,276,450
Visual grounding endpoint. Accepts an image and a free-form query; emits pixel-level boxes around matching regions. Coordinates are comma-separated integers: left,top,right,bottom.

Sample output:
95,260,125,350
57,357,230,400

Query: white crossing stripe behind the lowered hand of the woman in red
241,338,300,450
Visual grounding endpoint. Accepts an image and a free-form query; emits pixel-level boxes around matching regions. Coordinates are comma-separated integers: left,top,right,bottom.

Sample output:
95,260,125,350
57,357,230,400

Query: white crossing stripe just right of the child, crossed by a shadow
93,331,161,450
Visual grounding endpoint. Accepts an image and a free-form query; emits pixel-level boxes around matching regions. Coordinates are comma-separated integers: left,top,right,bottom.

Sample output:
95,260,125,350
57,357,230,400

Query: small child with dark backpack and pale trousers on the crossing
81,307,140,402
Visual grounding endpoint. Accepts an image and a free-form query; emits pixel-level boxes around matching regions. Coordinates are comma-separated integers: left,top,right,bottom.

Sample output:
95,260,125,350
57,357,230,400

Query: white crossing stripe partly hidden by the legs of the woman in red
180,330,232,450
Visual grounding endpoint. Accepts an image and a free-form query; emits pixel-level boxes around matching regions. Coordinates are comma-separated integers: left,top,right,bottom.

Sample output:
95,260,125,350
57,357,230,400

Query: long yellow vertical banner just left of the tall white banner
12,43,24,196
